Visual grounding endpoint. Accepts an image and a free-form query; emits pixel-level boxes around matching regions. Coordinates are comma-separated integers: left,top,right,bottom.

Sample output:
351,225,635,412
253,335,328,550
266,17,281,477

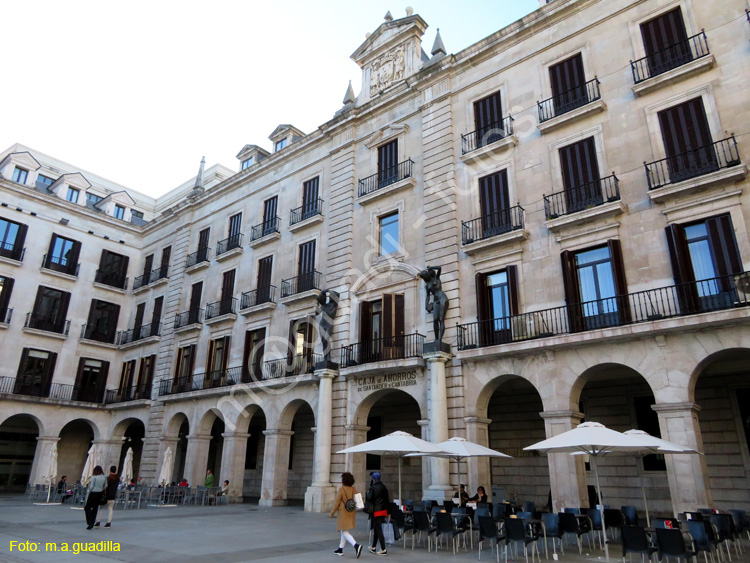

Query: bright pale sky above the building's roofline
0,0,539,197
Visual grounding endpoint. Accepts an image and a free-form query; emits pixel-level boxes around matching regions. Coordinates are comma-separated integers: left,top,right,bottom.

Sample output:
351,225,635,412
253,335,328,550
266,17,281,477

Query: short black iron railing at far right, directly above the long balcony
643,135,742,190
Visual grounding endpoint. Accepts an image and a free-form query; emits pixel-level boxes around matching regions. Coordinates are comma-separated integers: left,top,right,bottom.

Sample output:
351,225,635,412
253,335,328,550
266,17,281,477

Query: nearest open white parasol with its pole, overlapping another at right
524,422,658,561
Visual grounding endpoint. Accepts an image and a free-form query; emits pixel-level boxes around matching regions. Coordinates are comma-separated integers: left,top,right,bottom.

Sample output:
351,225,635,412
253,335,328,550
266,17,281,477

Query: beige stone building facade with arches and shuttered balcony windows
0,0,750,513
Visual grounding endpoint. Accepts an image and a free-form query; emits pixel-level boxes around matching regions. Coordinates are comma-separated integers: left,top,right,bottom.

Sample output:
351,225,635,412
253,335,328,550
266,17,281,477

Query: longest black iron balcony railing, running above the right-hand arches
457,272,750,350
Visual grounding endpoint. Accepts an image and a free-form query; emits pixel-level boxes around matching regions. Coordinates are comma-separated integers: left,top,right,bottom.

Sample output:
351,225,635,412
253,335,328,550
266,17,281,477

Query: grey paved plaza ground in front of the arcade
0,496,750,563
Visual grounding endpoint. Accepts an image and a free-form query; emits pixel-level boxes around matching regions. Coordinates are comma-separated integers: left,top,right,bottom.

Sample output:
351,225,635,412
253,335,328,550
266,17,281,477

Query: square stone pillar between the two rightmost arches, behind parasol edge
651,403,713,515
